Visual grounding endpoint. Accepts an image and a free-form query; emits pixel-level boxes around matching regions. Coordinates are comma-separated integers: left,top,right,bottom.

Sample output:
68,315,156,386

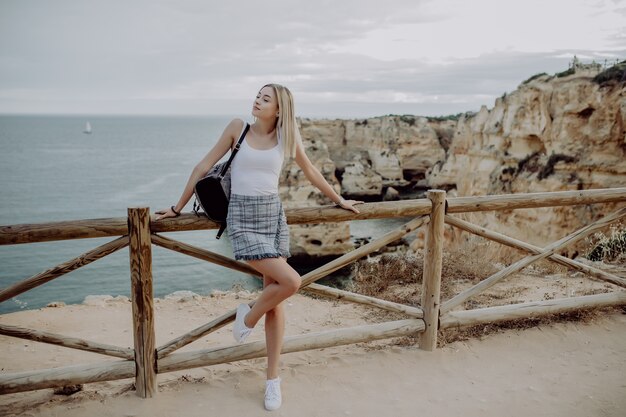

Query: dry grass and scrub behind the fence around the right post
352,213,626,348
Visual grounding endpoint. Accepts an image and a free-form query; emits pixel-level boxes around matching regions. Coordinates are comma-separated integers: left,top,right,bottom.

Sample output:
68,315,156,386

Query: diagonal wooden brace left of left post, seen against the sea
0,236,128,303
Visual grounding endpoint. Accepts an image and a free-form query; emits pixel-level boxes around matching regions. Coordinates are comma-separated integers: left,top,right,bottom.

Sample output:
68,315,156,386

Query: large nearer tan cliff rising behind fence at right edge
427,65,626,244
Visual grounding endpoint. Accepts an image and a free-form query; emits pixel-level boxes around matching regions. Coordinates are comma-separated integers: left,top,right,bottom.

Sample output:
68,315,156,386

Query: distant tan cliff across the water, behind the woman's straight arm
280,116,456,262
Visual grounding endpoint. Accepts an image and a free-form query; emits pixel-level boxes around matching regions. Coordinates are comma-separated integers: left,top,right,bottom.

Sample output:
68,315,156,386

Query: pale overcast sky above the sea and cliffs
0,0,626,117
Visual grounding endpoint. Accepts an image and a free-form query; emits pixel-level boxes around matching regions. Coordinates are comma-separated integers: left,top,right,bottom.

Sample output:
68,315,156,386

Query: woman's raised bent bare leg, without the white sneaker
244,258,302,328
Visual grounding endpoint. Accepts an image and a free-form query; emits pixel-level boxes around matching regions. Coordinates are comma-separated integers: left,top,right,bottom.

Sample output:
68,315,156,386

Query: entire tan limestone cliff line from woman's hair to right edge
283,63,626,254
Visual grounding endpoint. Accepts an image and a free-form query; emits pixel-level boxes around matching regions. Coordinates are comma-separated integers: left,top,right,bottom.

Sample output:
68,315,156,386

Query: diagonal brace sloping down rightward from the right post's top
446,215,626,287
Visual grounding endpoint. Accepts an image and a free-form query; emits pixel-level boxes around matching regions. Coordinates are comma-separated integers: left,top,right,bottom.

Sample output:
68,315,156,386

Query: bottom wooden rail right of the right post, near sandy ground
440,291,626,329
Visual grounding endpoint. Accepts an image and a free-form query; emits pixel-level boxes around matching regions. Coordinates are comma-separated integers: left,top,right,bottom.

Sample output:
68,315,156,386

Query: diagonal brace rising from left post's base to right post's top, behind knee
157,217,428,359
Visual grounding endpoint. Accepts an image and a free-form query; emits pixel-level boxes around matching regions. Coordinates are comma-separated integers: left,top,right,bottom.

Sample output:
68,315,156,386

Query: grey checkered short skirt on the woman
226,194,291,261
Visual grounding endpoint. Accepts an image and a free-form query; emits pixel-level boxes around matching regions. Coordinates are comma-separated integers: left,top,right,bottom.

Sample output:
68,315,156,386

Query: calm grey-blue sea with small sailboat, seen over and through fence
0,115,406,314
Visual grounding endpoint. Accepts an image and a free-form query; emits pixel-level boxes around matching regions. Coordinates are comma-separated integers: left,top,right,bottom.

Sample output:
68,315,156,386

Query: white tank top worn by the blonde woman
230,131,284,195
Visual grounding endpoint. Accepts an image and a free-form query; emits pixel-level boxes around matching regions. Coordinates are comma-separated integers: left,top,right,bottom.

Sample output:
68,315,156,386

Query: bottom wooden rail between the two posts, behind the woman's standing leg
159,319,424,373
